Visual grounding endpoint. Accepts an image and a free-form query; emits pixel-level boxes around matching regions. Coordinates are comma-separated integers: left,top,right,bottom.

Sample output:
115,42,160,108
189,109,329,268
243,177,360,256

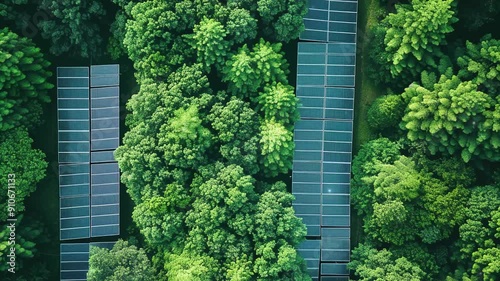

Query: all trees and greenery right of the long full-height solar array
349,0,500,281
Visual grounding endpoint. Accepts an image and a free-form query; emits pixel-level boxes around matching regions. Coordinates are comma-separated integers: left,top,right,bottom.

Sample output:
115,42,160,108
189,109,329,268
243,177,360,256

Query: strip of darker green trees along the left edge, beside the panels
0,23,53,281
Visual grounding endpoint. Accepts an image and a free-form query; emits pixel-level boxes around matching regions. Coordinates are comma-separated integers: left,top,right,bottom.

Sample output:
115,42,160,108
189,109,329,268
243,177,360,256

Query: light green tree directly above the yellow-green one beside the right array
257,83,300,128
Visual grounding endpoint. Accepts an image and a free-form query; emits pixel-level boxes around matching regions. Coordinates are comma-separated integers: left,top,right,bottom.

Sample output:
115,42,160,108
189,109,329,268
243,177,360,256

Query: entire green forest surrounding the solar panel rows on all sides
0,0,500,281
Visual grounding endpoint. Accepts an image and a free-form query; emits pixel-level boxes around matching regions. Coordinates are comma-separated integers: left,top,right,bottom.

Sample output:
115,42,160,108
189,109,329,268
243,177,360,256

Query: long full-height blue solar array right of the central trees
292,0,357,276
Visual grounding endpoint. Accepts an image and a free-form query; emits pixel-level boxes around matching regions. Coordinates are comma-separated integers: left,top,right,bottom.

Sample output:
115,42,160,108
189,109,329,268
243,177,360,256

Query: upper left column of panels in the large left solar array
57,67,90,163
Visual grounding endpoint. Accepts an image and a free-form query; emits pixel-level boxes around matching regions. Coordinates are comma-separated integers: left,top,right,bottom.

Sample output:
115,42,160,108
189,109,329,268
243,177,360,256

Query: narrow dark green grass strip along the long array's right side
351,0,384,246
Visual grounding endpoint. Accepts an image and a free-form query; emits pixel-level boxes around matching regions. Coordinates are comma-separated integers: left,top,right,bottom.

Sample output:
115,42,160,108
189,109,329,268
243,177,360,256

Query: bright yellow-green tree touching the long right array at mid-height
260,120,295,177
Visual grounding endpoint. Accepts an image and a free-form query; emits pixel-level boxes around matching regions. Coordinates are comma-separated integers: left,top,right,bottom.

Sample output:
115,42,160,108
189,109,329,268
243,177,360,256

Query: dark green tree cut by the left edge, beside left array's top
0,28,54,131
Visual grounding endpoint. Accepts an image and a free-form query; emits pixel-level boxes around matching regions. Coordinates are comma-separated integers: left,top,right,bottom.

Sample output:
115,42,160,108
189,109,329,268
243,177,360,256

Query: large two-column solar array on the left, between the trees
57,65,120,240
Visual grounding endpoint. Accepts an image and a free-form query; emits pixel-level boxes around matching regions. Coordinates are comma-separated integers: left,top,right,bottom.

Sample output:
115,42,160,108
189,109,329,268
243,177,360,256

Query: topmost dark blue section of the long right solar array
300,0,358,43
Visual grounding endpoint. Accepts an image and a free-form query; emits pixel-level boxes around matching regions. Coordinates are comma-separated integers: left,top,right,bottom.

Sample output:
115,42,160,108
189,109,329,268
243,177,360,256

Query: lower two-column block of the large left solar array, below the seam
59,162,120,240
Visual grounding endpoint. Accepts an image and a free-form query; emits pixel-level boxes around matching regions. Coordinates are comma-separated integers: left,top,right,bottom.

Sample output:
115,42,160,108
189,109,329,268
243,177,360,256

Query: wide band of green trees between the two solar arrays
116,0,310,280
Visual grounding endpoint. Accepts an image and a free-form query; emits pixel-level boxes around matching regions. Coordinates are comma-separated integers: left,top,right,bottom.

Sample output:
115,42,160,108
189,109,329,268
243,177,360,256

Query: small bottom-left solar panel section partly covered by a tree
60,242,115,281
